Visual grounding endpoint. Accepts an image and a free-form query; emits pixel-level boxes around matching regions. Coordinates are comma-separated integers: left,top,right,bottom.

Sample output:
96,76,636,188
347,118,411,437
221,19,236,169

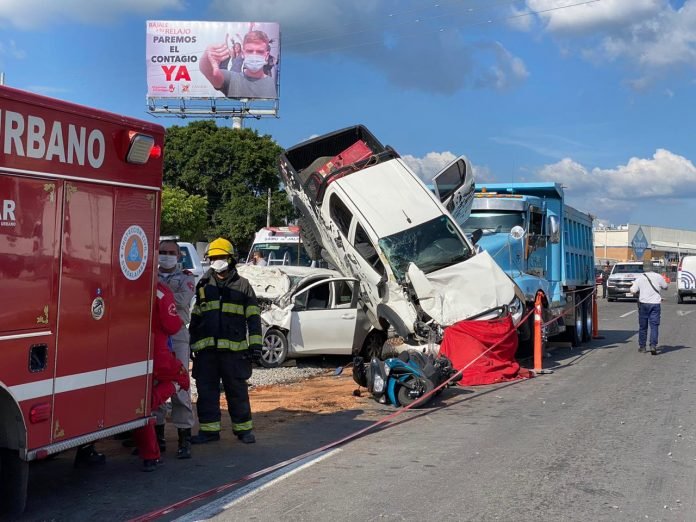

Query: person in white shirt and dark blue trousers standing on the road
631,261,667,355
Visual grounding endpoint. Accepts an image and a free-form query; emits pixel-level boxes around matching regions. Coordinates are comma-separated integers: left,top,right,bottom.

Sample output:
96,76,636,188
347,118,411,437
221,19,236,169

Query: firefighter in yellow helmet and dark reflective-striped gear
189,238,262,444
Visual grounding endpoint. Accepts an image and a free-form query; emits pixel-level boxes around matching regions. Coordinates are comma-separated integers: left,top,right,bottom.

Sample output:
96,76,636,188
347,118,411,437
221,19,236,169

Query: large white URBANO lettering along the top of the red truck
0,110,106,169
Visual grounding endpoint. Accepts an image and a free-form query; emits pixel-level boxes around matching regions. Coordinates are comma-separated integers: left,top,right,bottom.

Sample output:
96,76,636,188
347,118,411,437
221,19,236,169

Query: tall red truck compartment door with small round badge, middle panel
52,181,114,436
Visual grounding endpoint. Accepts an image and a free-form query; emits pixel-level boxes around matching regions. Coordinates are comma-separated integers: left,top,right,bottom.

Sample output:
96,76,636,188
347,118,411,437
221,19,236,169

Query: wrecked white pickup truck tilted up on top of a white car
279,126,524,345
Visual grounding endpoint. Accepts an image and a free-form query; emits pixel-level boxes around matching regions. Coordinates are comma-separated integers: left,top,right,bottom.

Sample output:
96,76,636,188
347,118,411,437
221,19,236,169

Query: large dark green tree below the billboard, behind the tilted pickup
164,121,295,250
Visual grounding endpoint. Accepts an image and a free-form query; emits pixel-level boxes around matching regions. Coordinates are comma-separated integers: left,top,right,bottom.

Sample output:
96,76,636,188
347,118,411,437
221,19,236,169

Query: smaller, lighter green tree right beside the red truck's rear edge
160,186,208,242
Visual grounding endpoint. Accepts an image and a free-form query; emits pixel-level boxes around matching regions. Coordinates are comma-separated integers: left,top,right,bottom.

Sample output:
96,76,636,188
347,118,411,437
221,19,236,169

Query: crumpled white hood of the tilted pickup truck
408,252,515,326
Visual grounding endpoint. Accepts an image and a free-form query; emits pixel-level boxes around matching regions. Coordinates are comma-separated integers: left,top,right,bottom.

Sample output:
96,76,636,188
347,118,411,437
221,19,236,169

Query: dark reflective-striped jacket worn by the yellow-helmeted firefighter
189,268,263,358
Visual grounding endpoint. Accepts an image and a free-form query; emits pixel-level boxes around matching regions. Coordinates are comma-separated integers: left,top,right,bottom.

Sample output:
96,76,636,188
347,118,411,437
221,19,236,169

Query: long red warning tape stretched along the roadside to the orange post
129,309,534,522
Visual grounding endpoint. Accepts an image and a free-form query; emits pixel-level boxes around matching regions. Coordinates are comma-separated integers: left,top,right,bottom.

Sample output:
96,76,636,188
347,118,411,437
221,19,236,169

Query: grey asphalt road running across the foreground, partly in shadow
16,285,696,521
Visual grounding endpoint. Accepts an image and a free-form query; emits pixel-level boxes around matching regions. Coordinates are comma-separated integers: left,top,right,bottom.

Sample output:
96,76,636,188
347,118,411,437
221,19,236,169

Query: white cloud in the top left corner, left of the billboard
0,0,185,30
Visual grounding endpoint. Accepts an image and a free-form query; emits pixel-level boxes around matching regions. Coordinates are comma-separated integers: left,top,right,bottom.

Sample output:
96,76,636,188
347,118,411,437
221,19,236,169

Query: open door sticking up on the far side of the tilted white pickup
433,156,476,223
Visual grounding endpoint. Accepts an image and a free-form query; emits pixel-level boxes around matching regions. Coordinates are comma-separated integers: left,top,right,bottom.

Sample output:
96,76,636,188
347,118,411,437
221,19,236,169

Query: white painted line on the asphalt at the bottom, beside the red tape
174,448,342,522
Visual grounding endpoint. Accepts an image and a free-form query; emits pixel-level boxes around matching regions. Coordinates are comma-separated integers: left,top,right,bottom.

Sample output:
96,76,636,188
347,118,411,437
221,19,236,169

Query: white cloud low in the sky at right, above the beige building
537,149,696,221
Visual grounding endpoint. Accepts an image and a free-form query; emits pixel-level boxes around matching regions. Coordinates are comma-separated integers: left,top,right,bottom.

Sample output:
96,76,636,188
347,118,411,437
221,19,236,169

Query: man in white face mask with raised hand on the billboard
200,30,277,99
